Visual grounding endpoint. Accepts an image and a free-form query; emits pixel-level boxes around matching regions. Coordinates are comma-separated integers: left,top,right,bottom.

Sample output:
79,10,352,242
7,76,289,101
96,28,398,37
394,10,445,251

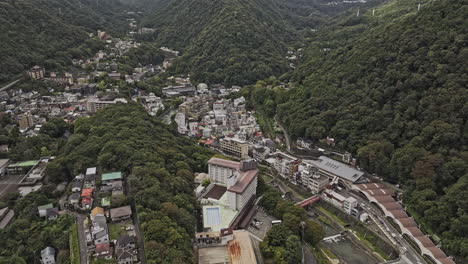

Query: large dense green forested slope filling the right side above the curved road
244,0,468,263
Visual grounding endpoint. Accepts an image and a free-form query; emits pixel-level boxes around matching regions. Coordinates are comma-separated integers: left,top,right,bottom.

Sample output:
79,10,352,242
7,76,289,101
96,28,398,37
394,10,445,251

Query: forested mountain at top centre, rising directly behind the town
142,0,380,85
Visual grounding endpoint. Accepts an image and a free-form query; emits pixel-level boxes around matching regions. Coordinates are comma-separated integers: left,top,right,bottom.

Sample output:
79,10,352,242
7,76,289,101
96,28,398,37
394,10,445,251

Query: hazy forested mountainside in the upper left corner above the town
0,0,133,83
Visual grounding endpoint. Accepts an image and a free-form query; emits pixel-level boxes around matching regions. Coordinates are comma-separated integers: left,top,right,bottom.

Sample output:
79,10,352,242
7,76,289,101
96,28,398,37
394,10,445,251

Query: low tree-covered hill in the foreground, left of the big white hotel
48,103,213,263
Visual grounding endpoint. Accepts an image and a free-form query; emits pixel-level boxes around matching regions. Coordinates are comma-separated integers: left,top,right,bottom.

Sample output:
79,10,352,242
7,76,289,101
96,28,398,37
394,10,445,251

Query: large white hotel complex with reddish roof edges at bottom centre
195,158,258,264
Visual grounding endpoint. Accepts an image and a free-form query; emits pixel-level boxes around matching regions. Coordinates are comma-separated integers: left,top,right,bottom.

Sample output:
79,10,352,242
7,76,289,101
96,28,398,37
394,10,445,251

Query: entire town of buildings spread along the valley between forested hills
0,11,454,264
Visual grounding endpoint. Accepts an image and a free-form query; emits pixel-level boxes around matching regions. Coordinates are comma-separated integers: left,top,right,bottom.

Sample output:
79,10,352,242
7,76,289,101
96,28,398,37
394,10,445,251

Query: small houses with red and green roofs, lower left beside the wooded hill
68,167,138,264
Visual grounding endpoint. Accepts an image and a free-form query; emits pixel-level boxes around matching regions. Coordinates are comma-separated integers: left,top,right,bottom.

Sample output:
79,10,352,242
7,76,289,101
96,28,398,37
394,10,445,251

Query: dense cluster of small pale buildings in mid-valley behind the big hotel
174,93,275,161
